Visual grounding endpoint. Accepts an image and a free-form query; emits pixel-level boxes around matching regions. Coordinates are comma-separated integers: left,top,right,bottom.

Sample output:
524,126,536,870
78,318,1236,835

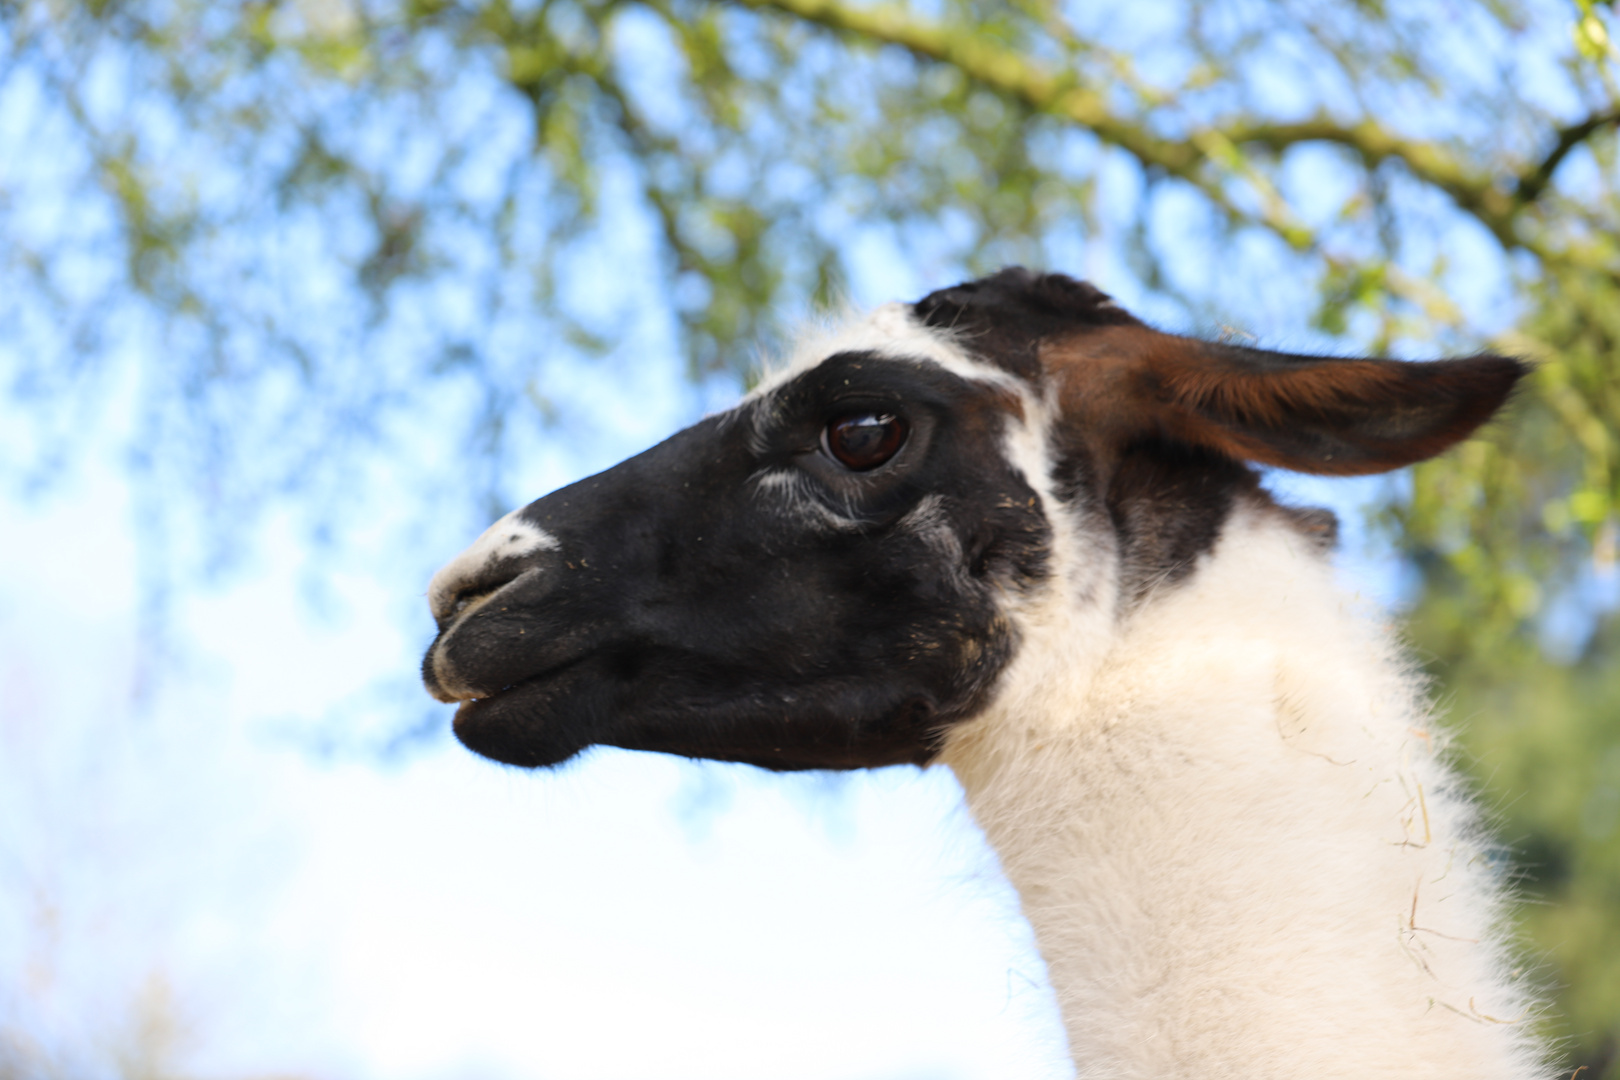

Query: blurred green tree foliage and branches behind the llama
0,0,1620,1080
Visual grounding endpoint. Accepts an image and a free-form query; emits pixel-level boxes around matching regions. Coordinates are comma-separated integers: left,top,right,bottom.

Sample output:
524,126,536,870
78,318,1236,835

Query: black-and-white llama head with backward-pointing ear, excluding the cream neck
423,269,1523,769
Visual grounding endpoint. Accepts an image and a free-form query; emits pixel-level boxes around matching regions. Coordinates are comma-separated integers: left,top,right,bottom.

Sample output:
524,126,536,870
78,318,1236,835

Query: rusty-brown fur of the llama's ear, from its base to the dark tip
1040,325,1528,476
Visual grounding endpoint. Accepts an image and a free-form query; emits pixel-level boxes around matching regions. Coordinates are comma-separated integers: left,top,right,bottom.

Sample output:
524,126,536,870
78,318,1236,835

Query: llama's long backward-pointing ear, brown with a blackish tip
1142,338,1529,476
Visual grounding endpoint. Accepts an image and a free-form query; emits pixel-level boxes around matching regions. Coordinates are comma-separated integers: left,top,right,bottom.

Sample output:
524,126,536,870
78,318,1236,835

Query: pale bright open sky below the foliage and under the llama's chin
0,307,1088,1078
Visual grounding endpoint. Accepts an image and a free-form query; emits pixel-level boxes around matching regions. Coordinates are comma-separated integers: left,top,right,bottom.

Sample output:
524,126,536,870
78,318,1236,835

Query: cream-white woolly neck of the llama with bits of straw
944,510,1545,1080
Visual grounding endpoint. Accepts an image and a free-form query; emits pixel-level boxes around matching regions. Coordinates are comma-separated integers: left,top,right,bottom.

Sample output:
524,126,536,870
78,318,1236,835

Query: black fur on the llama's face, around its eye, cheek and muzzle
424,353,1050,769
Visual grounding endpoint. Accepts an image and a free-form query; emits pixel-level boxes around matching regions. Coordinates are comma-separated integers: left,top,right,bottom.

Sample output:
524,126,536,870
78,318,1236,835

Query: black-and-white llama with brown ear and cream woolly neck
423,269,1549,1080
